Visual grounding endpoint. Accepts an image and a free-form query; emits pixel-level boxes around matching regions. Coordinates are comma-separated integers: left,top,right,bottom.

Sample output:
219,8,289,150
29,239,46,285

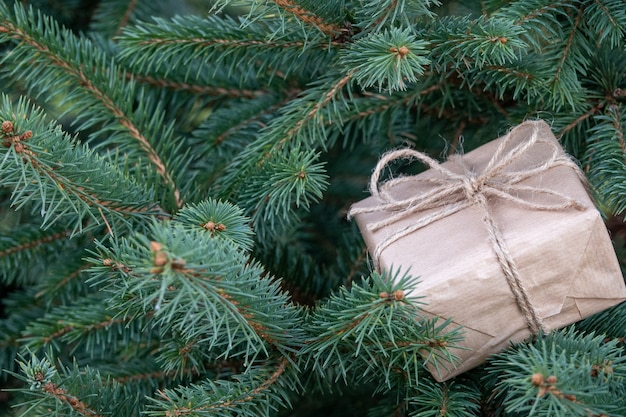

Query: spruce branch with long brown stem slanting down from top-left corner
0,4,182,207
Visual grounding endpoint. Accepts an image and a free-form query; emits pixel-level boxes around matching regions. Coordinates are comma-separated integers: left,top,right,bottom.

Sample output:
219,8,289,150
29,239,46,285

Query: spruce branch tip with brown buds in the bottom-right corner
490,329,625,417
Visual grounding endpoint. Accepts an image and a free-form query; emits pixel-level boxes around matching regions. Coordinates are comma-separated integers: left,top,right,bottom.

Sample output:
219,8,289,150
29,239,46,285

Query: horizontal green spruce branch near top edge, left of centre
117,16,339,82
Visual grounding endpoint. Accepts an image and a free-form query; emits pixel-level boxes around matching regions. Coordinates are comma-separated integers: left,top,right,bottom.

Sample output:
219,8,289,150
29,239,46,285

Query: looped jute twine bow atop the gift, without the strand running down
348,122,580,231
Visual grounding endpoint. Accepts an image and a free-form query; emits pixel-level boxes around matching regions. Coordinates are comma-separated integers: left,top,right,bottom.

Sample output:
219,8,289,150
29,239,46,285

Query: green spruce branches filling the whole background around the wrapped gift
0,0,626,417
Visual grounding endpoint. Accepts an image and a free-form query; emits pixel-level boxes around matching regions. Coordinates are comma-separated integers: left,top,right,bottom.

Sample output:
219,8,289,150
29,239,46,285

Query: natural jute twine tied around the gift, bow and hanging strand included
348,122,584,334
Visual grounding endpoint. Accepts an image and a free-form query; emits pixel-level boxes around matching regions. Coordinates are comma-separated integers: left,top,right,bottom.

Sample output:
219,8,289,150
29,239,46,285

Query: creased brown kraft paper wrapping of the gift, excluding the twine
353,121,626,381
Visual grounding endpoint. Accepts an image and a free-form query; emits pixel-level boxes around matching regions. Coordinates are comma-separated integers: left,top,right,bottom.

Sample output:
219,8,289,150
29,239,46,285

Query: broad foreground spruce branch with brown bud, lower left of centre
91,223,300,364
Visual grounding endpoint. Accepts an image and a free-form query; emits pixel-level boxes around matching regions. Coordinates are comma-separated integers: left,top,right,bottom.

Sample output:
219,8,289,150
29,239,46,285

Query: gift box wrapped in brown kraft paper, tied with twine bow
350,121,626,381
